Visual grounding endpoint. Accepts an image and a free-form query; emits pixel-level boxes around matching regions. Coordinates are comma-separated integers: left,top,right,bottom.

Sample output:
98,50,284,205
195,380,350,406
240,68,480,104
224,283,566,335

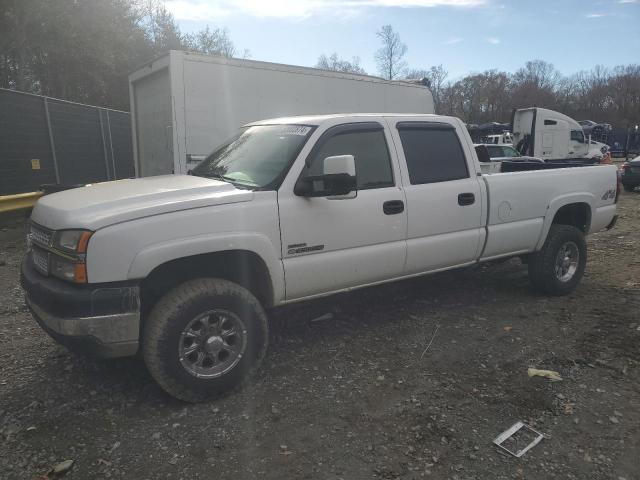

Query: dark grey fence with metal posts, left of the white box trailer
0,89,135,195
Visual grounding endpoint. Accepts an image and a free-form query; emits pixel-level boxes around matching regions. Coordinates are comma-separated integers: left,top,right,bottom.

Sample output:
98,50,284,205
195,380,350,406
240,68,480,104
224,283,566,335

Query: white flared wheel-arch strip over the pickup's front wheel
127,232,284,304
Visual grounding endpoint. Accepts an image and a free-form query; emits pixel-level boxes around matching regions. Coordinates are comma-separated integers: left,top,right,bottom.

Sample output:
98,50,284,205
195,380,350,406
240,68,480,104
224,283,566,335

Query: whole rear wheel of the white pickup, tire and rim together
528,225,587,296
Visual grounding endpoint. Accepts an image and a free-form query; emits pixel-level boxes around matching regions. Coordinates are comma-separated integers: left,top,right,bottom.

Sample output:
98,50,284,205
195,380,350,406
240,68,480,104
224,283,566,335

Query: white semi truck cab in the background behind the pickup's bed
512,107,591,160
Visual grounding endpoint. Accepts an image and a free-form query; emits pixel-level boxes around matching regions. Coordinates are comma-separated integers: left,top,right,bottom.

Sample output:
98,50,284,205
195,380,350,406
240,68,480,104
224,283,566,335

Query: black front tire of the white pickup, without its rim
142,278,269,402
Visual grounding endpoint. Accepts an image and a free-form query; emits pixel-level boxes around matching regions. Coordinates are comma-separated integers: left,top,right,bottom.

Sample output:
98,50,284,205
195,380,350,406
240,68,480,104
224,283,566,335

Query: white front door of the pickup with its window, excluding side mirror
278,117,407,300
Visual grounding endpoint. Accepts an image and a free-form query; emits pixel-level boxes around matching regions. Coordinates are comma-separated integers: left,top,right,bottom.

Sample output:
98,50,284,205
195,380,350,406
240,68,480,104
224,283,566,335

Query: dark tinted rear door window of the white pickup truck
398,122,469,185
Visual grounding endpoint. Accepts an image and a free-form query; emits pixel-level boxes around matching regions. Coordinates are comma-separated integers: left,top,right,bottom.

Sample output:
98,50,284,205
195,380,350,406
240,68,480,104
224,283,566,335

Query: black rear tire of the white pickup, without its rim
528,225,587,296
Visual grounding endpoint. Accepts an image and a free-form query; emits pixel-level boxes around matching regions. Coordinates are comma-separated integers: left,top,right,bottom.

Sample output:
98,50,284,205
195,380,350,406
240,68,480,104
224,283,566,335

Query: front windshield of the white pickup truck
191,125,315,190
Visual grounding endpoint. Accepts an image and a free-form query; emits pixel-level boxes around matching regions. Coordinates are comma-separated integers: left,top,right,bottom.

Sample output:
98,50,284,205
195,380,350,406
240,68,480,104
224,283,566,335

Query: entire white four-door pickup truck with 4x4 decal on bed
22,114,618,401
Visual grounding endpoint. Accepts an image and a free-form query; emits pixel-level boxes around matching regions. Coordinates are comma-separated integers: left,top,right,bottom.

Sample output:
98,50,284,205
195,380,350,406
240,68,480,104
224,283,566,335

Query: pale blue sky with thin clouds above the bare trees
165,0,640,80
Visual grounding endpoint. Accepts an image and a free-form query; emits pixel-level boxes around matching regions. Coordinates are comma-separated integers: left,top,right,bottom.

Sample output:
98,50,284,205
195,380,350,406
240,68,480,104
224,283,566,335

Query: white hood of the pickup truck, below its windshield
31,175,253,230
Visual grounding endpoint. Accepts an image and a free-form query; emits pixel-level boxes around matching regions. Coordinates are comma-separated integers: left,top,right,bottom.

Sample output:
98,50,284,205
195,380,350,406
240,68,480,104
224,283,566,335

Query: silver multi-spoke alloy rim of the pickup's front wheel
178,309,247,378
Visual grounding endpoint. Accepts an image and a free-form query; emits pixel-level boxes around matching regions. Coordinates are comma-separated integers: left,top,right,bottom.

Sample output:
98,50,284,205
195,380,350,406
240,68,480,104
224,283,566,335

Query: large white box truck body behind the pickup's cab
129,50,434,177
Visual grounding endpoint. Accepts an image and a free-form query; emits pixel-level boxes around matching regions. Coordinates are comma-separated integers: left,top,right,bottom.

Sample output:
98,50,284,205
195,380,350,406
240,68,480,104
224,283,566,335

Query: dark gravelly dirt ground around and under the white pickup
0,193,640,480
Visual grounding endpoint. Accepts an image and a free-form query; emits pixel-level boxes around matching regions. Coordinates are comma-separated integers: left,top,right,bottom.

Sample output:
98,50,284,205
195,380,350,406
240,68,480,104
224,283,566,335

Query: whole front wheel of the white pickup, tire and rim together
143,278,268,402
